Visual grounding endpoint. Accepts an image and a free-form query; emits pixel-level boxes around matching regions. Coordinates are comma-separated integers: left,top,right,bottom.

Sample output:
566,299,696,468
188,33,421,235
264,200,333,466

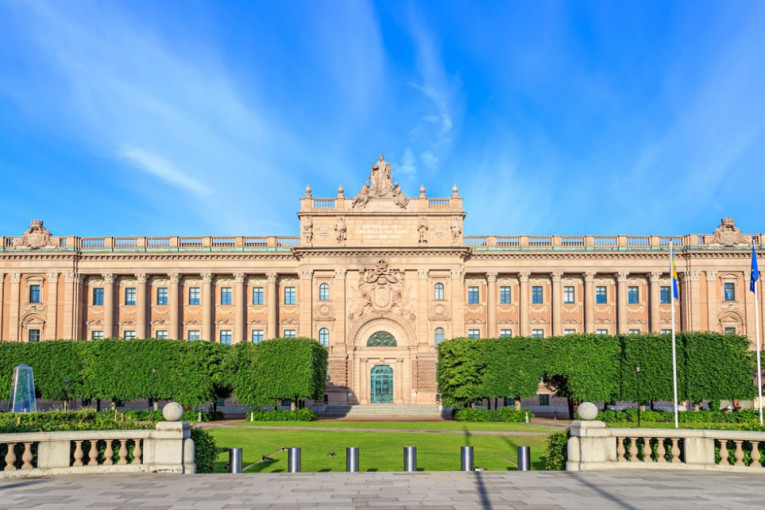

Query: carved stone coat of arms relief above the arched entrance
349,260,415,320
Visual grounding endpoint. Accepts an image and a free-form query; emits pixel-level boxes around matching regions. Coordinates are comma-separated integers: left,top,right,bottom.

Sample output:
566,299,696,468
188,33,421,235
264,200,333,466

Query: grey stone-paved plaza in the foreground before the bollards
0,471,765,510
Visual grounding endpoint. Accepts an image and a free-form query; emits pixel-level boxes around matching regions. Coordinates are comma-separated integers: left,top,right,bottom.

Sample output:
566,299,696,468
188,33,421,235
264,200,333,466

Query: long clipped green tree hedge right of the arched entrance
437,332,755,407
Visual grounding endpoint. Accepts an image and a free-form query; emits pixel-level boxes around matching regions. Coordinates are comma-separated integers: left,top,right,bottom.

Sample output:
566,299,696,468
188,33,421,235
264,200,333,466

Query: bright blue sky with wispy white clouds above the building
0,0,765,236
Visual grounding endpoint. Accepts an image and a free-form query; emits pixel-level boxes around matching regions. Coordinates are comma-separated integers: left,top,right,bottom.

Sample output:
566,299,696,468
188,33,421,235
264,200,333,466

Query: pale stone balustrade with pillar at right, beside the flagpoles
566,420,765,473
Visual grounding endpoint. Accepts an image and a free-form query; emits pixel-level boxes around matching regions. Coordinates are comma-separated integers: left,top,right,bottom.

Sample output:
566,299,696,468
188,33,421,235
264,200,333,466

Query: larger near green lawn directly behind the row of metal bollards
210,428,549,473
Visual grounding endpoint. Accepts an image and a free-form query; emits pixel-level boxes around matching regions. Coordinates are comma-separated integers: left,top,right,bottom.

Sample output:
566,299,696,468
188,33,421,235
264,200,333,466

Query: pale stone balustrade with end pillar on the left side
0,422,196,478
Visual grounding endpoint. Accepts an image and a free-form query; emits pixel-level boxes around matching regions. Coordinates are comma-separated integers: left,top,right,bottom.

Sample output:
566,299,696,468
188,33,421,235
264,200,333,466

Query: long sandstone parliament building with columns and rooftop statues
0,156,765,405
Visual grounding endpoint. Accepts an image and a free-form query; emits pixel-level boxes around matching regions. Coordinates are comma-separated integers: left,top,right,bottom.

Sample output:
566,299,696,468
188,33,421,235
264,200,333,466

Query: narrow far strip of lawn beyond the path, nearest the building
224,420,555,433
